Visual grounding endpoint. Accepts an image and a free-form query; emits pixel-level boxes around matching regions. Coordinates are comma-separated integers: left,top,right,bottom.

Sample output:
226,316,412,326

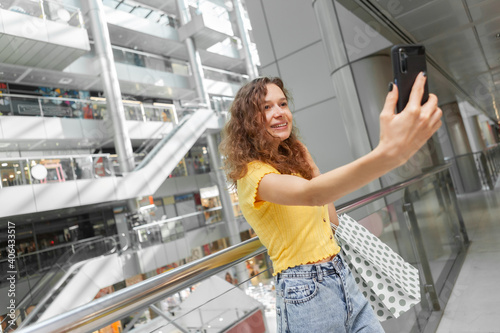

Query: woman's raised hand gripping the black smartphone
376,73,442,167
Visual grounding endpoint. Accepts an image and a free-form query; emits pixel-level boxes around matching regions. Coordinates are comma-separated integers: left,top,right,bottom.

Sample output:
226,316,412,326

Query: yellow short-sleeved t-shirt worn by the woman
237,161,340,275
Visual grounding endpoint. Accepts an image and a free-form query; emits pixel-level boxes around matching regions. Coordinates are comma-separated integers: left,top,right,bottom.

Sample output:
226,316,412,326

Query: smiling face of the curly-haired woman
262,83,293,141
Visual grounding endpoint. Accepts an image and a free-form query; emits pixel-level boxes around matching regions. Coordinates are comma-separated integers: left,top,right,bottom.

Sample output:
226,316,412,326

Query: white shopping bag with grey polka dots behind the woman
332,214,420,321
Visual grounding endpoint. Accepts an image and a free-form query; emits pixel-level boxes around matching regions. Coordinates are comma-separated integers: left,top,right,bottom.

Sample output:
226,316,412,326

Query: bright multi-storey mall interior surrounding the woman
0,0,500,333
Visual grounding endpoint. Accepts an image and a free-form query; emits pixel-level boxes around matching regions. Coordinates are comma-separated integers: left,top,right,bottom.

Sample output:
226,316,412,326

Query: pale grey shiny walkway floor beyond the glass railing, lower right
436,183,500,333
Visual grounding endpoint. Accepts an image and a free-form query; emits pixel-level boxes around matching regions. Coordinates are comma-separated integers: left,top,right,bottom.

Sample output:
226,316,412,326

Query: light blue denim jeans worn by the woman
276,254,384,333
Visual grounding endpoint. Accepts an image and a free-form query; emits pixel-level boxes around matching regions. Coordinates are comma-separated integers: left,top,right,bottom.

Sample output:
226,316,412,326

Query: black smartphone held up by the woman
391,44,429,113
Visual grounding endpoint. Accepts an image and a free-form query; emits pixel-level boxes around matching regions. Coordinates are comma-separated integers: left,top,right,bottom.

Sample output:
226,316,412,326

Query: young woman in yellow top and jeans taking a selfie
220,73,442,333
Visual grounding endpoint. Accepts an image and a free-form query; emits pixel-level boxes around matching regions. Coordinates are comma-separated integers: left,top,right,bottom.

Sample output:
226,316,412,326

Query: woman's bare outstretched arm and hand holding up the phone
257,73,442,206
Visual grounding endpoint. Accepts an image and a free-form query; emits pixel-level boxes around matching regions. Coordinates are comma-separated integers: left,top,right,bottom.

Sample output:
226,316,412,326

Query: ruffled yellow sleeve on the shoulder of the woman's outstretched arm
237,161,280,209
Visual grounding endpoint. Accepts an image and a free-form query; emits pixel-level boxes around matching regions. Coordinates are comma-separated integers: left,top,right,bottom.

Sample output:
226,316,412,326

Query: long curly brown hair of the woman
219,77,313,185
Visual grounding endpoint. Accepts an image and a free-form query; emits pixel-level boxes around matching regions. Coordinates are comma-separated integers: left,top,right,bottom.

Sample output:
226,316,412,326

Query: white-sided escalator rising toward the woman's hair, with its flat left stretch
0,109,224,217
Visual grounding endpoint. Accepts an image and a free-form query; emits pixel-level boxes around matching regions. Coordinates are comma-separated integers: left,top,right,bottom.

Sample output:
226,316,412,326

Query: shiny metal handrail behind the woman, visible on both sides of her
17,164,450,333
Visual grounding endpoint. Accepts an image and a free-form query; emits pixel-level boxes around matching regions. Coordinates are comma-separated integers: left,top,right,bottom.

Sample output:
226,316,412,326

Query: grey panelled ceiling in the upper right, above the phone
346,0,500,122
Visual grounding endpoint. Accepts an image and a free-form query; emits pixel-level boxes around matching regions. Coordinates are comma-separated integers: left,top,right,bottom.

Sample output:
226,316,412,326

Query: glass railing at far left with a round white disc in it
0,154,114,188
